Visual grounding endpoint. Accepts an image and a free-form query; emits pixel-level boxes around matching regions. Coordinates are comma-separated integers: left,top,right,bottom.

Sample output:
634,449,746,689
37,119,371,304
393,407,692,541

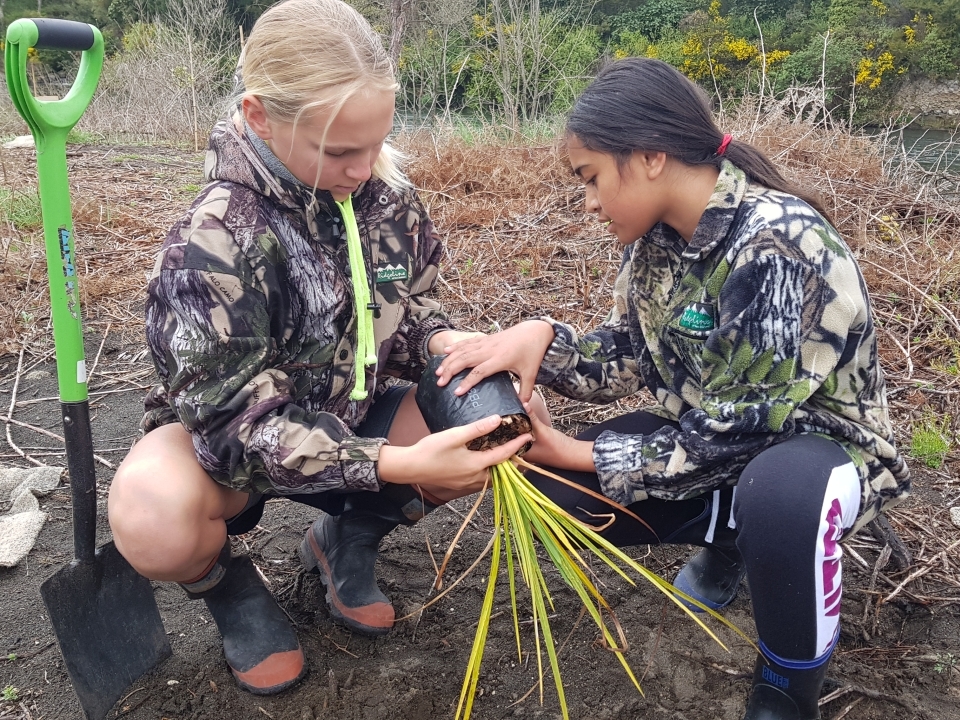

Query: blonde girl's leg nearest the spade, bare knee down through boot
108,424,306,695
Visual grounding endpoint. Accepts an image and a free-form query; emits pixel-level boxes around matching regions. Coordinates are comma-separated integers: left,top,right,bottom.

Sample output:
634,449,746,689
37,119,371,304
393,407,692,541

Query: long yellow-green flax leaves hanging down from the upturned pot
450,457,753,720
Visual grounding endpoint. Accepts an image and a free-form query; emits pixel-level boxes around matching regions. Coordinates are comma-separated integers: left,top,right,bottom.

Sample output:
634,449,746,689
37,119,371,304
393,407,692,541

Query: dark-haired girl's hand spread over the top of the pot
437,320,554,402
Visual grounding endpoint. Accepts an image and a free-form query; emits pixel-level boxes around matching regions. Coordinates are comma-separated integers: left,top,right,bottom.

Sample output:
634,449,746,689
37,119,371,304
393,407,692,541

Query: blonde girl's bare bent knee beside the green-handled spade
108,424,248,582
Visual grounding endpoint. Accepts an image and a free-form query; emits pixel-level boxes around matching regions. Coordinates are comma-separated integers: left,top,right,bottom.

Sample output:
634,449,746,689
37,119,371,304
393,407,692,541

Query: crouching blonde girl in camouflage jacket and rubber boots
109,0,531,694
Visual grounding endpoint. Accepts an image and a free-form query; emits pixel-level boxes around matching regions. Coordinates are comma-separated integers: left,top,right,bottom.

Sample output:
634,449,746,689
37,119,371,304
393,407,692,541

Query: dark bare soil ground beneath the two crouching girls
0,356,960,720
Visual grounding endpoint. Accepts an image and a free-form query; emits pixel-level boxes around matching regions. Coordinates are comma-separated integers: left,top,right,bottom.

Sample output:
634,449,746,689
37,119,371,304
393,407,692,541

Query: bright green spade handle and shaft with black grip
4,19,103,402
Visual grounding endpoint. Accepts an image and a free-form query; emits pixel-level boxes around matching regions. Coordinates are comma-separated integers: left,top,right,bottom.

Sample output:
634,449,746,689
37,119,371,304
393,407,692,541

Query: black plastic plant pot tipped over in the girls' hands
417,355,531,454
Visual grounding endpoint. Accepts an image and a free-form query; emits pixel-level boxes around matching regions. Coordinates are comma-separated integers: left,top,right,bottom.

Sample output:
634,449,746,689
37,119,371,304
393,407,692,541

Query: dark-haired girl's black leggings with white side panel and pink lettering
530,411,859,664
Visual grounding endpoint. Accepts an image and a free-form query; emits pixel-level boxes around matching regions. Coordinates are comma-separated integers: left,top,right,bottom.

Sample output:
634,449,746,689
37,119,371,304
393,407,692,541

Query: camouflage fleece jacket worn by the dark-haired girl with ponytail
538,162,909,527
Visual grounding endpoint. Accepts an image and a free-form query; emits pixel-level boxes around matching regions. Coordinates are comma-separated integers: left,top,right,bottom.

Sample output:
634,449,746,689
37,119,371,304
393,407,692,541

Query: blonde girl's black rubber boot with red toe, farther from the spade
300,484,437,635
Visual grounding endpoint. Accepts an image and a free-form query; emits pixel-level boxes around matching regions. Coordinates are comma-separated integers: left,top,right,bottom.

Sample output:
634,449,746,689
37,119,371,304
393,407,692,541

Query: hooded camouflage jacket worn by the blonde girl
143,116,450,494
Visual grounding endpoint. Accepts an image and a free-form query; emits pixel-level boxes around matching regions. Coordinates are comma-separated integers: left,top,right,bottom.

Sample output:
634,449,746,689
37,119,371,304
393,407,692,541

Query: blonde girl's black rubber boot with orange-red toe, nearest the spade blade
180,540,307,695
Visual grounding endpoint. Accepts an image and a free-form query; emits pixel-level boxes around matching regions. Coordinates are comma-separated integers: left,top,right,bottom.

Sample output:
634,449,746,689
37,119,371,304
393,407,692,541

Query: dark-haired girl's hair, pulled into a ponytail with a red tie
567,58,830,221
